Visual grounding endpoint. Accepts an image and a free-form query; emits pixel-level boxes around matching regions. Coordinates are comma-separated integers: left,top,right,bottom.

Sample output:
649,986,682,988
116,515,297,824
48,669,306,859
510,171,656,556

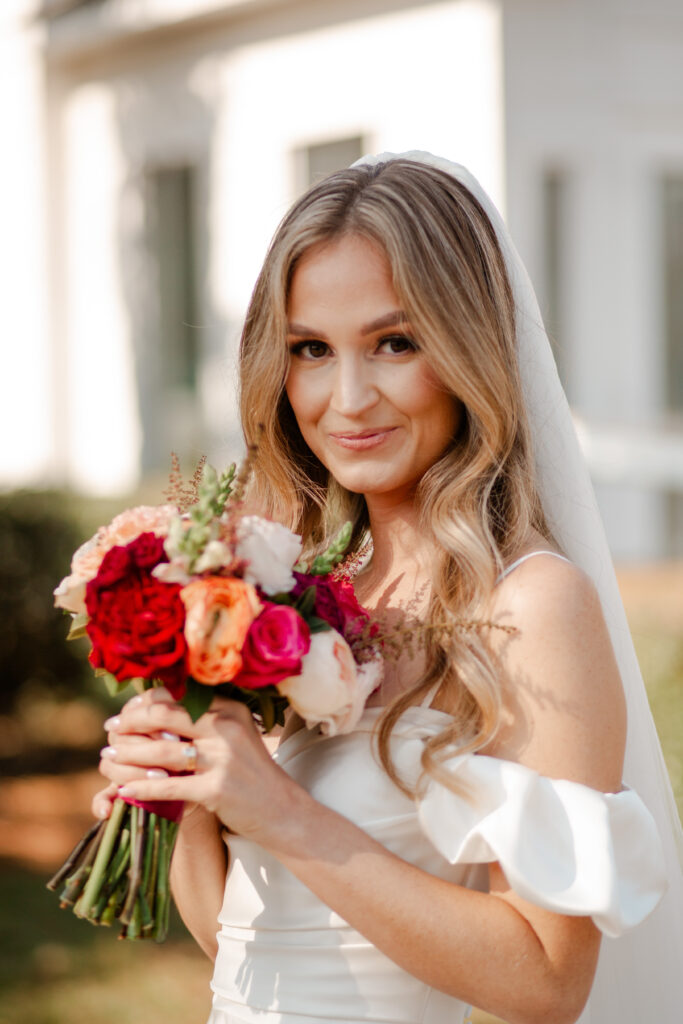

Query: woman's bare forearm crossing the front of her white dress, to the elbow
264,793,598,1024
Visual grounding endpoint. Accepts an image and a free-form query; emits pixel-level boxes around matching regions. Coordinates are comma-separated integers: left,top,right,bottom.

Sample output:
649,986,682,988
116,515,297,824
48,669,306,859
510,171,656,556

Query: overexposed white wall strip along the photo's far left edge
0,0,52,486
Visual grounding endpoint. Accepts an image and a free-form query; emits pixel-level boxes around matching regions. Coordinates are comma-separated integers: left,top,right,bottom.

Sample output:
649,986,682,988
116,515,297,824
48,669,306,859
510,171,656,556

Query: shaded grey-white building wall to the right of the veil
503,0,683,559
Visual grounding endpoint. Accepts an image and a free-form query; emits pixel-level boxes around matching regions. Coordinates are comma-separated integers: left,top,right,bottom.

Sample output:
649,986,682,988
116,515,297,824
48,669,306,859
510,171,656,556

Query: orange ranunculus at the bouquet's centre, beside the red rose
180,577,261,686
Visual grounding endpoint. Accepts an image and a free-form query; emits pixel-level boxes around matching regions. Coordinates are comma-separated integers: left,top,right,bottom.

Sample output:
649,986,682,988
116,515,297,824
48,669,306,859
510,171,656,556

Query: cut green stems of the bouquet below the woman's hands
47,800,179,942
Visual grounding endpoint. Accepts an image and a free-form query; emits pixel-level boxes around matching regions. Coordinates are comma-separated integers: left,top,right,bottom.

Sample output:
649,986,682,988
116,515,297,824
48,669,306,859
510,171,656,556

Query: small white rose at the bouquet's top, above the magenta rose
236,515,301,595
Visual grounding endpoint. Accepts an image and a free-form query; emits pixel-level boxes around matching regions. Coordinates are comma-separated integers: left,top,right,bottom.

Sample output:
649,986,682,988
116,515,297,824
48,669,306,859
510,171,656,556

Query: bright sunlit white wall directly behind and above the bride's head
213,2,504,358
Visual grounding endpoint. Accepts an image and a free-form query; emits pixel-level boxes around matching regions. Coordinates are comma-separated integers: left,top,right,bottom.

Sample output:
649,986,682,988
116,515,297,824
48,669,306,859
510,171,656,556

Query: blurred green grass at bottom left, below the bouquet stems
0,865,211,1024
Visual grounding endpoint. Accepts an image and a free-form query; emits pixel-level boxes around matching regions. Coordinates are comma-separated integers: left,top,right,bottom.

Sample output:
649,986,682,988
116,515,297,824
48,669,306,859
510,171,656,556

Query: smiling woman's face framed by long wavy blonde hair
287,234,462,504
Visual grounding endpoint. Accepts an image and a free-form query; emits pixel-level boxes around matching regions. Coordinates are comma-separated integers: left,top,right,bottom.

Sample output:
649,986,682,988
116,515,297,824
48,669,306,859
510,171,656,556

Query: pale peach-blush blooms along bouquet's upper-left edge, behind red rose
54,505,178,614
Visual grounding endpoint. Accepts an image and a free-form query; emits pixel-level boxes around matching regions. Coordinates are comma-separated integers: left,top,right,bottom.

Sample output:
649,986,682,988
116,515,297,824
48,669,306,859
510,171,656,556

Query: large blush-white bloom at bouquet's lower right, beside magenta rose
278,630,382,736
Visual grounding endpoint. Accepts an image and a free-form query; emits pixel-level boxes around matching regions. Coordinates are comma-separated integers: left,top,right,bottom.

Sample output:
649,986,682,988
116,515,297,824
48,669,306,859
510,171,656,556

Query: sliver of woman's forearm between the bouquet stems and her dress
171,804,227,961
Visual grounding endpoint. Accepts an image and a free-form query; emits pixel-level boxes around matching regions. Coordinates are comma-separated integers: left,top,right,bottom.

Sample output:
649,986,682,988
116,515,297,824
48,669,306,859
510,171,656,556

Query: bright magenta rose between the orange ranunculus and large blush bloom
232,602,310,690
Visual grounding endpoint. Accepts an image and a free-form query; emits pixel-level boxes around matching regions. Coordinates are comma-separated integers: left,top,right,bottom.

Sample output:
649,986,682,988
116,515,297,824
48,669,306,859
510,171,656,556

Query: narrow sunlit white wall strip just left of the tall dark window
63,83,140,495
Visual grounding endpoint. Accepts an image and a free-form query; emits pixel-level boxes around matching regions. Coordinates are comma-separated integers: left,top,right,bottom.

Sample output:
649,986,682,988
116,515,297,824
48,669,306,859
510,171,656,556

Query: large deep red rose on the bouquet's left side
85,534,187,698
